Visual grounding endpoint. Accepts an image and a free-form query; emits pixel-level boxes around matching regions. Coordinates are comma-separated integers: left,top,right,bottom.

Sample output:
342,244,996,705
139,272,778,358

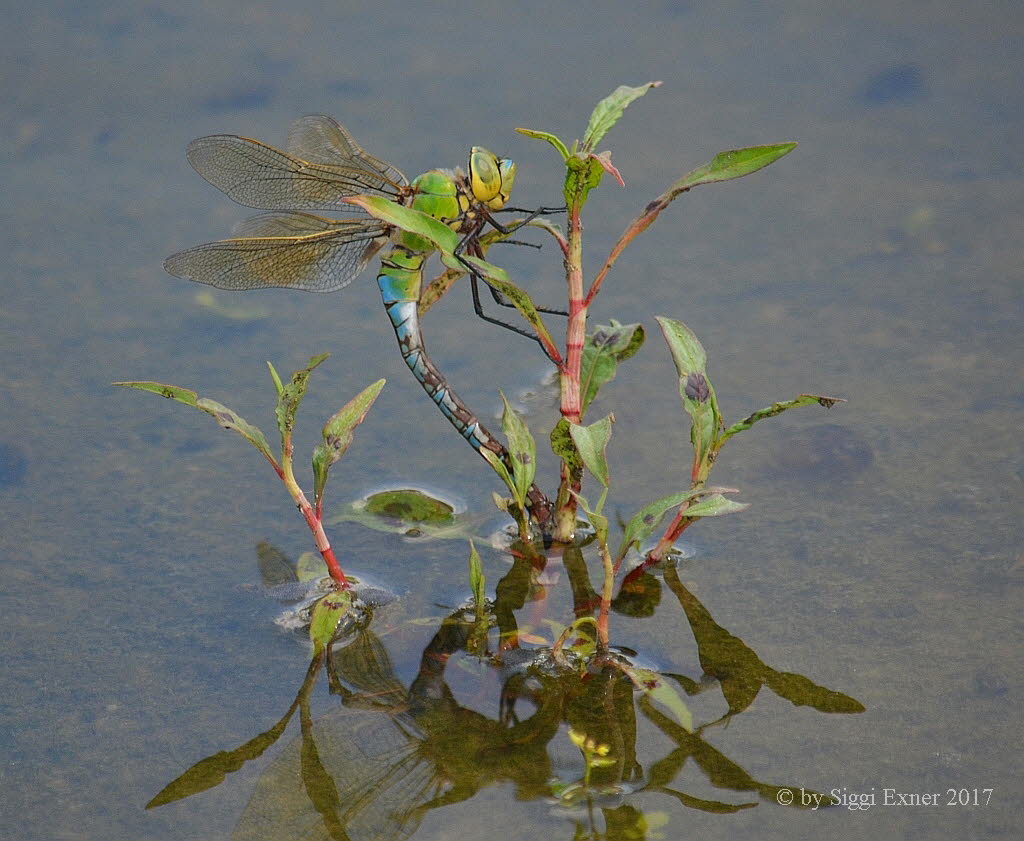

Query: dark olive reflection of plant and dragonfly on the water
147,528,864,841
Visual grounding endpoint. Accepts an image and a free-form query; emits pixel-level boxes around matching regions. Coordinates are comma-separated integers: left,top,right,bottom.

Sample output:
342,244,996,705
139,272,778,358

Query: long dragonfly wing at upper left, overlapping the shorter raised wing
185,134,407,213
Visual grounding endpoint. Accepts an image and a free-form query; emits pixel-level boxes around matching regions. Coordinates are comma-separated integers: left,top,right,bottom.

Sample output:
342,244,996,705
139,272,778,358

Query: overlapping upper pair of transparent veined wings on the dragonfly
185,116,409,213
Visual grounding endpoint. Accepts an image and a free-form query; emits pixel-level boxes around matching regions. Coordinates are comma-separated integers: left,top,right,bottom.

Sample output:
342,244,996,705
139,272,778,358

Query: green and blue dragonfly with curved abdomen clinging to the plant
164,115,551,523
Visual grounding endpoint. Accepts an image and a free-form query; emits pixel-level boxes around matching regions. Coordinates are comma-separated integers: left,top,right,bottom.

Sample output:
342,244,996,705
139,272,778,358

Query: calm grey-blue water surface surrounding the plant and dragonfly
0,0,1024,841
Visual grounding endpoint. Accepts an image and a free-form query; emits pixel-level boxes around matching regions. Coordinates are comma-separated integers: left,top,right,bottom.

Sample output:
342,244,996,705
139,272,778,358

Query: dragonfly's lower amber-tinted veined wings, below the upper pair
164,213,387,292
